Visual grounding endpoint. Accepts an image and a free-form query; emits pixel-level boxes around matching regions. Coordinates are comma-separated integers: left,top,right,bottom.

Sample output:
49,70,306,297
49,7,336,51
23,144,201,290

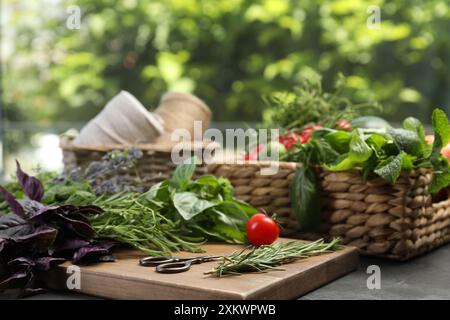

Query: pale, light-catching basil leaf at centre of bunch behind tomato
173,192,216,220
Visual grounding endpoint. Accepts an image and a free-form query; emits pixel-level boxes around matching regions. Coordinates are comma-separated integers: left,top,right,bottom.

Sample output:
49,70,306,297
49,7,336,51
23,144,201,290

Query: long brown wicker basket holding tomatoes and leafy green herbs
209,162,450,260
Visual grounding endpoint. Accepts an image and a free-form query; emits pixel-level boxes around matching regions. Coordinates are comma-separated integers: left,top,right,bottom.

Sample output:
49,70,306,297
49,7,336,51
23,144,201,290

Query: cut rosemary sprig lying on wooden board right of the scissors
205,238,340,277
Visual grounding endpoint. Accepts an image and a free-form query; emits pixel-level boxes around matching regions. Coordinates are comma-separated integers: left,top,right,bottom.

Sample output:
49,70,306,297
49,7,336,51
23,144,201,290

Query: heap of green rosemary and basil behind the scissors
19,159,257,255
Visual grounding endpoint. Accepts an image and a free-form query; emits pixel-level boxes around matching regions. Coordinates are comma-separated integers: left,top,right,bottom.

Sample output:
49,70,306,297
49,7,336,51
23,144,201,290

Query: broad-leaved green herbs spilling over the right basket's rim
287,109,450,229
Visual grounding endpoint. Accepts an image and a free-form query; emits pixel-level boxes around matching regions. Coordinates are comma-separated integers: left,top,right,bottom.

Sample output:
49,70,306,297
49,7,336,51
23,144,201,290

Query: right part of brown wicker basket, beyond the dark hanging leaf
319,169,450,260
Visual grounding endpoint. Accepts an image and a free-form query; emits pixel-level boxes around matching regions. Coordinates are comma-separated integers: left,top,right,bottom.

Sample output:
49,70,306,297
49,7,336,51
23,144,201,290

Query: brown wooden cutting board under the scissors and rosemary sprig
43,239,359,300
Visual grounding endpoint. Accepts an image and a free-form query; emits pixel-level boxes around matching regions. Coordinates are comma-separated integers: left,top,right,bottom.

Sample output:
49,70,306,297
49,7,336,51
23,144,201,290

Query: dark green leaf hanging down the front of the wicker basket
290,166,322,231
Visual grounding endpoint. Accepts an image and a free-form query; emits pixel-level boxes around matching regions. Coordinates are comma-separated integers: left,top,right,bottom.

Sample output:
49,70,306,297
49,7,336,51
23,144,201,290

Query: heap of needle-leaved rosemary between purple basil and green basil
67,192,205,255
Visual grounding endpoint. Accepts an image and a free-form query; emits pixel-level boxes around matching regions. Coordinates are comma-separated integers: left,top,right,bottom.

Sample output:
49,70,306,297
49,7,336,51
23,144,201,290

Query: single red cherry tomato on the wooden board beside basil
246,213,280,246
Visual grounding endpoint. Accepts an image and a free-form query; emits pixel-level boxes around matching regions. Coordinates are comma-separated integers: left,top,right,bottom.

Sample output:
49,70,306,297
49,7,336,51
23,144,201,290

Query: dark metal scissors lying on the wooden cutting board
139,256,222,273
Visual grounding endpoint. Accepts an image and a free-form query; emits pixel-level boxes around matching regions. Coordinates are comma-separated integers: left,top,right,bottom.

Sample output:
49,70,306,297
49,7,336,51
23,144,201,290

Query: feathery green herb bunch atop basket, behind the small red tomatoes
266,74,380,130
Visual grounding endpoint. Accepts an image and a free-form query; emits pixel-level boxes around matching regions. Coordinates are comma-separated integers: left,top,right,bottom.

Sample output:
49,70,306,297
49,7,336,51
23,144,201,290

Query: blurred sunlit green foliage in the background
3,0,450,123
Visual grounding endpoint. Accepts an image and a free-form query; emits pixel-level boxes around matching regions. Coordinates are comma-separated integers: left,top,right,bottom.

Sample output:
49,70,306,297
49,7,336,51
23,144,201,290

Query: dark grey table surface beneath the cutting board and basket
0,245,450,300
